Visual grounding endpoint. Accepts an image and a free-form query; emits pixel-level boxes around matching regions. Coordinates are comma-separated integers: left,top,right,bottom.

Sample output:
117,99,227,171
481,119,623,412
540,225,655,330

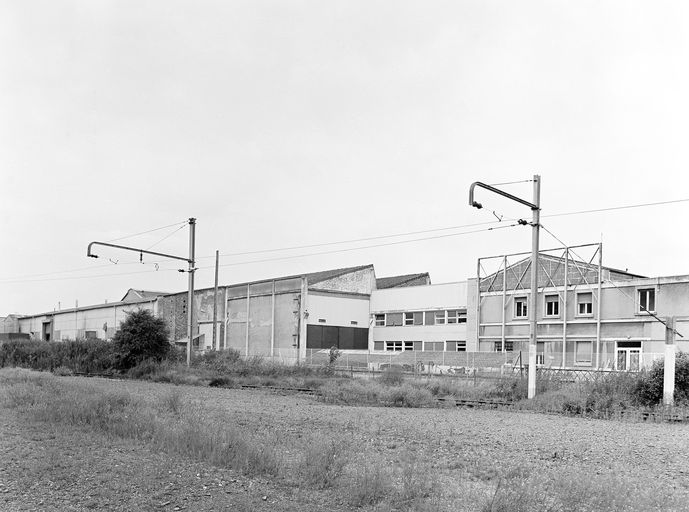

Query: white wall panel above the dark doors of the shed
307,290,369,327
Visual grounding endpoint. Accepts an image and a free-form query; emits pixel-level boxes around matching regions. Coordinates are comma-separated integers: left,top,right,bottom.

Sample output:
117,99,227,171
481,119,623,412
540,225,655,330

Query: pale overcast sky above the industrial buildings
0,0,689,315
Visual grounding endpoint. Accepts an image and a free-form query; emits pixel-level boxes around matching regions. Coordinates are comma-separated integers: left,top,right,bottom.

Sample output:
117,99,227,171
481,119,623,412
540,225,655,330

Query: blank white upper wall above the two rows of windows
371,281,467,313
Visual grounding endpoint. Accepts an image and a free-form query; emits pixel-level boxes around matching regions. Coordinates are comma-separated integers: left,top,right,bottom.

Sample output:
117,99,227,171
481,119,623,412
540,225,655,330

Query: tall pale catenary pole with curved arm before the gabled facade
469,174,541,399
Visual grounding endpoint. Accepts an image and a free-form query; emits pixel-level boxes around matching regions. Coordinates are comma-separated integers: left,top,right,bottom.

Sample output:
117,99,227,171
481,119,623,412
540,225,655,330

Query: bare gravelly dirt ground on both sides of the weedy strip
0,377,689,511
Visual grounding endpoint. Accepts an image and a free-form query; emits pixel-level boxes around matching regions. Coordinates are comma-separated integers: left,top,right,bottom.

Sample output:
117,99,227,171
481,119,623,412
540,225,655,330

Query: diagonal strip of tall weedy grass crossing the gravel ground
0,369,686,512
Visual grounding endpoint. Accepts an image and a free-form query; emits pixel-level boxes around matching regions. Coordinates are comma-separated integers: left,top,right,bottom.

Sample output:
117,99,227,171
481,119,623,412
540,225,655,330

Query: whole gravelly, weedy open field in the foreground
0,369,689,511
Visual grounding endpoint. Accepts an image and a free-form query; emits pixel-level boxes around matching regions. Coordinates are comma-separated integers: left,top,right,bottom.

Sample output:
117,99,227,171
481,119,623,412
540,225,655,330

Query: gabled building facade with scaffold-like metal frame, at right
469,244,689,370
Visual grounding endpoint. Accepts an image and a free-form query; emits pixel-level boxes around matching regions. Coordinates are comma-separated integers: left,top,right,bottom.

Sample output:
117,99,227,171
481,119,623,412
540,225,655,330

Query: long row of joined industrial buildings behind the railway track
5,244,689,370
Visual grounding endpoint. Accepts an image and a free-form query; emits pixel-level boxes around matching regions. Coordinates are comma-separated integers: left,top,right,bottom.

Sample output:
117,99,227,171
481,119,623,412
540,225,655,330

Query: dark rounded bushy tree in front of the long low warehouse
113,309,170,370
